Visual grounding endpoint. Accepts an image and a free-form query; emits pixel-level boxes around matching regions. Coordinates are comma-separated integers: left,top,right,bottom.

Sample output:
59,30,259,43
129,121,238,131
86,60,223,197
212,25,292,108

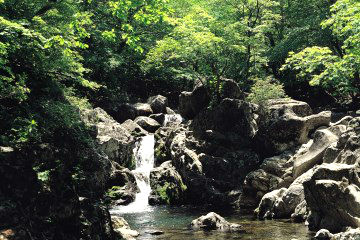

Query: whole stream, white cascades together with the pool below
110,116,314,240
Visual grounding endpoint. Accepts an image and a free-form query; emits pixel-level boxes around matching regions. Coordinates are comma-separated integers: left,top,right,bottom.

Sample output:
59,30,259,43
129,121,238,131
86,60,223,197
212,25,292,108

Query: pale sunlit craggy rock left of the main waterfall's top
82,108,135,166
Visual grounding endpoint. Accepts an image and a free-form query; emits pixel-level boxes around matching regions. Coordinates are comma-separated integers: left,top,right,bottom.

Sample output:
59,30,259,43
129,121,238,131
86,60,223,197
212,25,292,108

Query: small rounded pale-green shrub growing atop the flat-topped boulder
247,77,286,105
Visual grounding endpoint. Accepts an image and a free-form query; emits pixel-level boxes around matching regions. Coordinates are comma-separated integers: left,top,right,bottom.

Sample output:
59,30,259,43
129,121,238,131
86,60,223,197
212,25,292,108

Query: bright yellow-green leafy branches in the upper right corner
282,0,360,100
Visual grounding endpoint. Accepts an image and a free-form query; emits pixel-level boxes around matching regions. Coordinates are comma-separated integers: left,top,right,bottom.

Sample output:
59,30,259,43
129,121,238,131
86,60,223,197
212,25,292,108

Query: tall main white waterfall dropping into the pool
113,135,155,213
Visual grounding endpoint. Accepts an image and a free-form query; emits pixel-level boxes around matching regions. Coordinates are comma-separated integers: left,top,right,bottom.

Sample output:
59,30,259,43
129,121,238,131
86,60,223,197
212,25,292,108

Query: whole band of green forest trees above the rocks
0,0,360,146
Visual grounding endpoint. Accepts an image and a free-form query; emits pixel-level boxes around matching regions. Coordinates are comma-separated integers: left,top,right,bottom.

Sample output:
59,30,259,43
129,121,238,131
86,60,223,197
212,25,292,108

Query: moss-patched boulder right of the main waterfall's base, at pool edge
149,161,187,205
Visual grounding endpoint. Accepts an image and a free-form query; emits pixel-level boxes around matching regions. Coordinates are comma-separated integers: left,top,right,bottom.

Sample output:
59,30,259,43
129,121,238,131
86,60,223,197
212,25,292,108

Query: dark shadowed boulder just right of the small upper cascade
179,85,210,119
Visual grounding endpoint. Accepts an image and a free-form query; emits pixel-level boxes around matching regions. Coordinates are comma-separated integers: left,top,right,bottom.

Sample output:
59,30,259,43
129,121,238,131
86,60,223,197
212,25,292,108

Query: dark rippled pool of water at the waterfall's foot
112,206,313,240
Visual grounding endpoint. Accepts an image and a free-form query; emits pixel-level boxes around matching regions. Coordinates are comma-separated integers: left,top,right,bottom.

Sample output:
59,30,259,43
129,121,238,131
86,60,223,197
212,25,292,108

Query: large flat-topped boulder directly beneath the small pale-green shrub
257,99,331,154
